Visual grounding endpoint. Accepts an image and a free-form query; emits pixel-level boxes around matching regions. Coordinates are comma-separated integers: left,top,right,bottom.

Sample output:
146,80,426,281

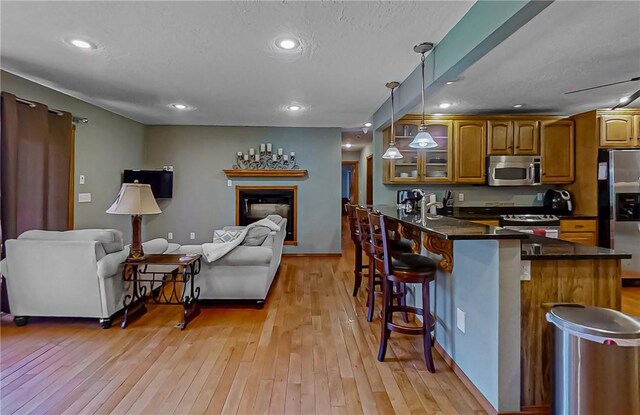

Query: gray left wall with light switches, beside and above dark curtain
0,71,144,240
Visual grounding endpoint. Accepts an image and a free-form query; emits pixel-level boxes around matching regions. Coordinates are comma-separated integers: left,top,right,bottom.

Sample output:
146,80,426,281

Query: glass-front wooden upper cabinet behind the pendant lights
384,120,453,183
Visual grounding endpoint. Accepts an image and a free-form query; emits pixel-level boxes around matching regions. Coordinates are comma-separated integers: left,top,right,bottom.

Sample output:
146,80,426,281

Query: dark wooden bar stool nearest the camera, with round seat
369,213,436,373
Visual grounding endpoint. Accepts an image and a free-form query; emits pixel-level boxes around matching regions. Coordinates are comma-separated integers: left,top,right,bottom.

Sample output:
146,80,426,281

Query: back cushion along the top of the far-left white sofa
18,229,124,254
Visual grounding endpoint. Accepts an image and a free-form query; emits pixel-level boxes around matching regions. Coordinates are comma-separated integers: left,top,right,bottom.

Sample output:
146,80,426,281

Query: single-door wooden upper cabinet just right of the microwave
540,120,575,184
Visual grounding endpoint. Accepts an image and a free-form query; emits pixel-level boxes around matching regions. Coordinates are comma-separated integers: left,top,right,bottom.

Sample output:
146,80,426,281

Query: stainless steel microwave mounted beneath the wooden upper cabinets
487,156,542,186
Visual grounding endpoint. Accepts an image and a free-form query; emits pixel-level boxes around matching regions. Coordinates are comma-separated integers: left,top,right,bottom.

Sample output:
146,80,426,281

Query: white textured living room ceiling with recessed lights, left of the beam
0,1,473,127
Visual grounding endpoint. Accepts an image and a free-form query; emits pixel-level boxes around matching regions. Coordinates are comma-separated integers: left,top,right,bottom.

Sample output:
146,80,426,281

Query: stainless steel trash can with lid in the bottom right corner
547,305,640,415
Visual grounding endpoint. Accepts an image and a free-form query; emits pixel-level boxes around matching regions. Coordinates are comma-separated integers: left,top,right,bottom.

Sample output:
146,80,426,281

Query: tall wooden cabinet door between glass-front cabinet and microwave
453,120,487,184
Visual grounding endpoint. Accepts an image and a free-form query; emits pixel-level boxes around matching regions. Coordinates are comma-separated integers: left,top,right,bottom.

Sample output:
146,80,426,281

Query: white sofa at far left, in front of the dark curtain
0,229,179,328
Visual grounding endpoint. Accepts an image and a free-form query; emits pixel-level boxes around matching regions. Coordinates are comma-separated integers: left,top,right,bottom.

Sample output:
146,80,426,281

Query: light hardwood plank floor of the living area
0,224,640,414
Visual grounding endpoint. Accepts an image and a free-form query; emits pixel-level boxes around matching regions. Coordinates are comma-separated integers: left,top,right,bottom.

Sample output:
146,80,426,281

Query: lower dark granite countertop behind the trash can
521,235,631,260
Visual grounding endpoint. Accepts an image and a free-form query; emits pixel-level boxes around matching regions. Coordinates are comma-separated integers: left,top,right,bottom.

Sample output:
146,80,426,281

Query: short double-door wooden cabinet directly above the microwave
487,120,540,156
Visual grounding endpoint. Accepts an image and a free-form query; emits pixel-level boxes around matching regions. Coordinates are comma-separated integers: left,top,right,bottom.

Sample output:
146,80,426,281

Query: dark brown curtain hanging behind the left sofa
0,92,72,311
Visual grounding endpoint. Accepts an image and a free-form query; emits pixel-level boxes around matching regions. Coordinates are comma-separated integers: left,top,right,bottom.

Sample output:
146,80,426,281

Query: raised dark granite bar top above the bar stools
373,205,527,240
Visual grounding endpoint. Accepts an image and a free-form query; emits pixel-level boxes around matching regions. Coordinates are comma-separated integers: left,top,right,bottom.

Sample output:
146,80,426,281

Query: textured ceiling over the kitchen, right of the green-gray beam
412,1,640,115
